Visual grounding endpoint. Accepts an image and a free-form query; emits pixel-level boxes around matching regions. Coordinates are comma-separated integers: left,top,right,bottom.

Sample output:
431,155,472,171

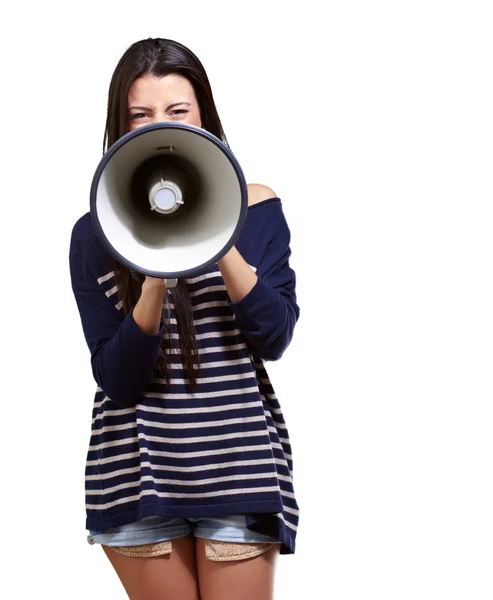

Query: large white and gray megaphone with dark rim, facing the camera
90,123,248,287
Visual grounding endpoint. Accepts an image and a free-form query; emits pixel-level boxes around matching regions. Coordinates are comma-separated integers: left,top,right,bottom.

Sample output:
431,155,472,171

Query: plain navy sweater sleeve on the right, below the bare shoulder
229,213,300,360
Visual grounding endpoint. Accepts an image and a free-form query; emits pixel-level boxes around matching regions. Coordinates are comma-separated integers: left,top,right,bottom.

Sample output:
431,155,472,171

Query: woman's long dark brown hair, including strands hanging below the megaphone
103,38,228,388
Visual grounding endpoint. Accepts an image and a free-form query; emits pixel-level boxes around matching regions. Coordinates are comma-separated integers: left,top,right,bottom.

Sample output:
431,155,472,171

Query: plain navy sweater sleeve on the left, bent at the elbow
70,233,165,408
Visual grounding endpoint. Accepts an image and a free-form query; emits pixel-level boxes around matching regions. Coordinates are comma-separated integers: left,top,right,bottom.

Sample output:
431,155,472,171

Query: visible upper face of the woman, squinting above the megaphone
128,73,202,131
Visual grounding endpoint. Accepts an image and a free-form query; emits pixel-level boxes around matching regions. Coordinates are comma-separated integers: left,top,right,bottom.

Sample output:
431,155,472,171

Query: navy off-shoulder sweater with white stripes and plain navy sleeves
70,198,299,554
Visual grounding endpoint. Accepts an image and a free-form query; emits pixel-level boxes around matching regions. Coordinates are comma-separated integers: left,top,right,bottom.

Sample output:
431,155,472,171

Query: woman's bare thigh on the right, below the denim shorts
195,538,280,600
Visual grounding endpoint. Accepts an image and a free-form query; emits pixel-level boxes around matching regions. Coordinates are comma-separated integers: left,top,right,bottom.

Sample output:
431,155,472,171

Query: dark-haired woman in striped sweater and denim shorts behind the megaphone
70,39,299,600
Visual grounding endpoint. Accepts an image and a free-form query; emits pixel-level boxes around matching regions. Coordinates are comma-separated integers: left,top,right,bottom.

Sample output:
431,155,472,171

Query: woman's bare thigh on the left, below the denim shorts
103,535,200,600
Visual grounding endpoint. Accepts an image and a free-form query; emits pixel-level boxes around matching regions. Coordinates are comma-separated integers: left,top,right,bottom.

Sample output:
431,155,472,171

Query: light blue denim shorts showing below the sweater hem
87,515,279,546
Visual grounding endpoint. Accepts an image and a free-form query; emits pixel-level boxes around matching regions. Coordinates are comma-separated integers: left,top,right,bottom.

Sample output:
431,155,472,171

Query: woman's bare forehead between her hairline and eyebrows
128,73,196,107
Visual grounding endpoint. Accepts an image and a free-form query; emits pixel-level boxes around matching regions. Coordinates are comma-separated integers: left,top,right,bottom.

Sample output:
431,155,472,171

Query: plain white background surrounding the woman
0,0,493,600
